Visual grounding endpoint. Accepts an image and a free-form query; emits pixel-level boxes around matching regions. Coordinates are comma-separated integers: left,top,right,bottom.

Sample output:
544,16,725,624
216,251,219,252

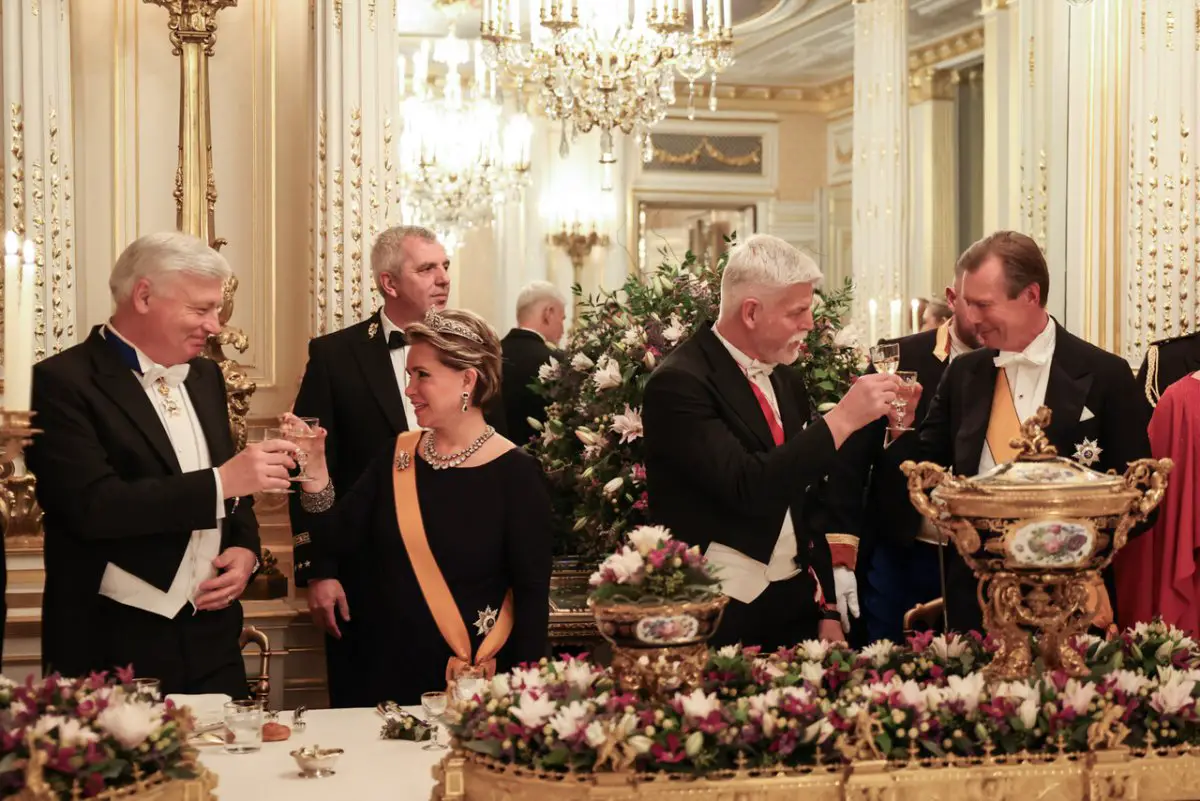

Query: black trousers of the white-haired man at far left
86,596,250,698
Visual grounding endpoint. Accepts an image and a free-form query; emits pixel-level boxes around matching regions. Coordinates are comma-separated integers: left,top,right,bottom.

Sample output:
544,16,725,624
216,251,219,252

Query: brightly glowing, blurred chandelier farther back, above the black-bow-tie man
400,6,533,247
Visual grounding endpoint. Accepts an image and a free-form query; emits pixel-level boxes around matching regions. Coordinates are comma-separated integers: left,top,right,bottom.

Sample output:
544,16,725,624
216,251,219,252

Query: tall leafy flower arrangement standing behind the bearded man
532,244,866,556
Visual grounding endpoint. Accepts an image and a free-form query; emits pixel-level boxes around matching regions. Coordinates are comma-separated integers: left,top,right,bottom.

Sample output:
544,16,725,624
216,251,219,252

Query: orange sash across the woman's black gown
392,430,512,685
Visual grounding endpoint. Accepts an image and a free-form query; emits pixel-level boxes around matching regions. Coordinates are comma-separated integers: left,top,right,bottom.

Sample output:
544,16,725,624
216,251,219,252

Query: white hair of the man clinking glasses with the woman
108,231,233,303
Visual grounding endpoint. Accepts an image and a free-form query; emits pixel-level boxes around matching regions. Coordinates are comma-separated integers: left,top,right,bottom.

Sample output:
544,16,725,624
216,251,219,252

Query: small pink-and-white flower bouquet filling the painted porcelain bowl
589,525,720,603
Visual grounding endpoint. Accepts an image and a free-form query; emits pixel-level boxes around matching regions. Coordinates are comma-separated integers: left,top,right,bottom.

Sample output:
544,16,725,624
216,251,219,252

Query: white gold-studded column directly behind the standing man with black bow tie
310,0,401,336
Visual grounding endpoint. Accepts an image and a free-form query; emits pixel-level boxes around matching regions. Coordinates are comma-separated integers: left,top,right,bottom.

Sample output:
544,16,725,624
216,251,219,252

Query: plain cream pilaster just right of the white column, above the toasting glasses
905,67,960,299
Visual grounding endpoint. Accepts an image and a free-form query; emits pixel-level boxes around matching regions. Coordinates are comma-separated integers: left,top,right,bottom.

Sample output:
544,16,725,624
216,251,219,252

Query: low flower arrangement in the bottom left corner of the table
0,670,194,797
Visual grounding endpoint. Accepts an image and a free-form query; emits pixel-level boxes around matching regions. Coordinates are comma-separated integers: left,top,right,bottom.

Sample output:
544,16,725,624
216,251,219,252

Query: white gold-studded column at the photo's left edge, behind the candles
0,0,77,360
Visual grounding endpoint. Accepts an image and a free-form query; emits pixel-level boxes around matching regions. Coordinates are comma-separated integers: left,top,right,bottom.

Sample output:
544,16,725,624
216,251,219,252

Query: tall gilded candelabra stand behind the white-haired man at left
145,0,256,448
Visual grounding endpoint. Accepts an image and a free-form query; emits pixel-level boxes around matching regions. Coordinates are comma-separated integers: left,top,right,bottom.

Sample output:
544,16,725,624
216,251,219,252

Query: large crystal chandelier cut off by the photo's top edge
480,0,733,172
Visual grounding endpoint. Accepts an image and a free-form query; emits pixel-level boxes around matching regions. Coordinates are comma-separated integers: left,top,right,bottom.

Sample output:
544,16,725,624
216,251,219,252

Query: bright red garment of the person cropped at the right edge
1115,372,1200,634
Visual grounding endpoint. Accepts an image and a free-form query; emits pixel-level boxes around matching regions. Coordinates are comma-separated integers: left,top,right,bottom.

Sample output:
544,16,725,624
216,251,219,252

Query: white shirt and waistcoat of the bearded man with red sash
704,326,800,603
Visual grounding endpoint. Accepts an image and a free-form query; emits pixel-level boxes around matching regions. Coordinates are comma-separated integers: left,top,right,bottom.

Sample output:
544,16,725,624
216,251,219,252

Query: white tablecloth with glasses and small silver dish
199,709,446,801
